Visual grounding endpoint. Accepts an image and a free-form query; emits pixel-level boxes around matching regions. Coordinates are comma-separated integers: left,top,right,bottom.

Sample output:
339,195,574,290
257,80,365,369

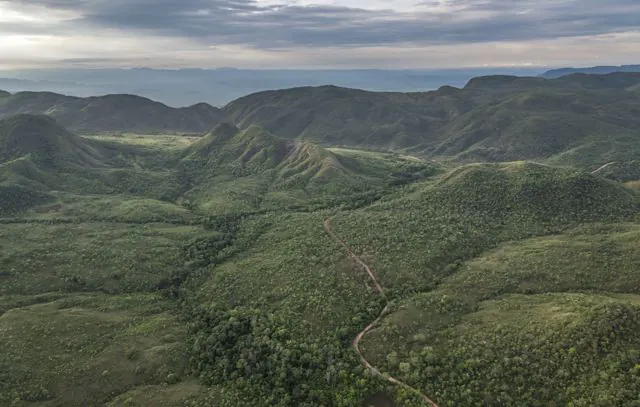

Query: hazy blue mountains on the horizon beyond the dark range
0,68,541,106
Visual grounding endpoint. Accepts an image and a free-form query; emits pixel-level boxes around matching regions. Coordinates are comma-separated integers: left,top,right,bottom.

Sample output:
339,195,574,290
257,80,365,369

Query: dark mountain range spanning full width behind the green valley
0,73,640,175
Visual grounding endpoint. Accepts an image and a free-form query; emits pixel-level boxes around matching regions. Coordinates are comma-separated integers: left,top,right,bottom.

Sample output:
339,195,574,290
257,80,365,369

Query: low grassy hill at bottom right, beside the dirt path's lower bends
365,224,640,406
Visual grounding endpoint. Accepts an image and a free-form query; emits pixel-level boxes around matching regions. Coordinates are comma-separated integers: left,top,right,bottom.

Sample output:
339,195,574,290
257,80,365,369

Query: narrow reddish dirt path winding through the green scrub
324,218,438,407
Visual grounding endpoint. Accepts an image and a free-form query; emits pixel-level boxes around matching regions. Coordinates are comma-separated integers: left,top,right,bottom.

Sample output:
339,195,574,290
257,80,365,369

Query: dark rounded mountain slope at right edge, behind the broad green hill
431,89,640,167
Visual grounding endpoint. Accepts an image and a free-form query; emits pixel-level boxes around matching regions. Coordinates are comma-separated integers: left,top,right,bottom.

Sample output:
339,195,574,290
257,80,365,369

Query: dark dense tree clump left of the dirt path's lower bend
191,307,381,407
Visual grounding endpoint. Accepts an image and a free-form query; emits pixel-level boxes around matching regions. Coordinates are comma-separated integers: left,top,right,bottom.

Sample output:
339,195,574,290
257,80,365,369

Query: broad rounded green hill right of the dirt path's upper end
334,163,638,292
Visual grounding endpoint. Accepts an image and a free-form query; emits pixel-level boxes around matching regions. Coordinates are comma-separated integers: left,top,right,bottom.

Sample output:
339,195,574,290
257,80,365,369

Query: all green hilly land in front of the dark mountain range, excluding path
0,112,640,407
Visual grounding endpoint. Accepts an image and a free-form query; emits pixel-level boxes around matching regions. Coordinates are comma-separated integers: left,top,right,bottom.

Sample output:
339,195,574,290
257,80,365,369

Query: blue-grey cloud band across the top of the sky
5,0,640,48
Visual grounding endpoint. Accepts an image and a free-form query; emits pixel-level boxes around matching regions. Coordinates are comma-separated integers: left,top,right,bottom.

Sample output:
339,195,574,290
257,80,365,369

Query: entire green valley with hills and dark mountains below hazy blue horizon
0,73,640,407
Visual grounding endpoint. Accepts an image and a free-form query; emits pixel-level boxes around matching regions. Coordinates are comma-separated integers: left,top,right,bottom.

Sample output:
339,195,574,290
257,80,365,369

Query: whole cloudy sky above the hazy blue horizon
0,0,640,69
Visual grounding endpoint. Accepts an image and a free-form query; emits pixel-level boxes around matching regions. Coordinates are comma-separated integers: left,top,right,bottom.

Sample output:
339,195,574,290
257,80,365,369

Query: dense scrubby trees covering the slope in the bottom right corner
410,303,640,407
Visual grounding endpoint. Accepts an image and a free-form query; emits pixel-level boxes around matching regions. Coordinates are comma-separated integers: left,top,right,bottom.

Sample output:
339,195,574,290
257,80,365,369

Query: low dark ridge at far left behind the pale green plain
0,92,224,133
